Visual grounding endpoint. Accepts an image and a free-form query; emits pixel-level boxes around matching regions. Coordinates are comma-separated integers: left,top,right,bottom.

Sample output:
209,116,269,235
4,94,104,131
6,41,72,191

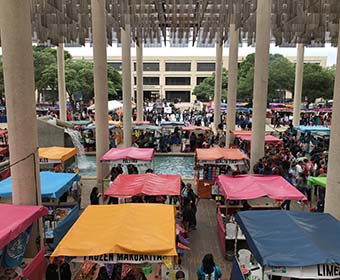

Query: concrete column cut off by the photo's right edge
325,26,340,220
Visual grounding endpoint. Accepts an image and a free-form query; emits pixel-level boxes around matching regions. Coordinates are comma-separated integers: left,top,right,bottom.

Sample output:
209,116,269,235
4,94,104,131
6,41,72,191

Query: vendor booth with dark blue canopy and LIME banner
230,210,340,280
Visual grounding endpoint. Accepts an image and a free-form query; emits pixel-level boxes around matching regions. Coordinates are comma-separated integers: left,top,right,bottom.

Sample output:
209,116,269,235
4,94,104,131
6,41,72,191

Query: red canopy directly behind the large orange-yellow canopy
105,173,181,197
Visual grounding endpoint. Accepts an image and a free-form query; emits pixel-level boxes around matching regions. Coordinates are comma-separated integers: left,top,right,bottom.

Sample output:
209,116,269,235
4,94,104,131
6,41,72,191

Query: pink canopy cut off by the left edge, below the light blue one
0,204,48,249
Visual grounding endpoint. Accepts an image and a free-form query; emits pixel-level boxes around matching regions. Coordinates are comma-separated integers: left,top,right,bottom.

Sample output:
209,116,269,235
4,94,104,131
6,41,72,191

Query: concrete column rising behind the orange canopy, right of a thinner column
225,24,240,148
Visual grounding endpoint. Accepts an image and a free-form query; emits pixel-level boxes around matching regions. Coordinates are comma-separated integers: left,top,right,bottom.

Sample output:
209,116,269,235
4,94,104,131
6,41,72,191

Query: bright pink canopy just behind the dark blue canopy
217,175,307,200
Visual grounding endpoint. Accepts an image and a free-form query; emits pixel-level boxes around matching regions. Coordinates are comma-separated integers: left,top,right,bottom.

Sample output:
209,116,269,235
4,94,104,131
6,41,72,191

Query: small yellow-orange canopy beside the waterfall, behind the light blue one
39,146,78,163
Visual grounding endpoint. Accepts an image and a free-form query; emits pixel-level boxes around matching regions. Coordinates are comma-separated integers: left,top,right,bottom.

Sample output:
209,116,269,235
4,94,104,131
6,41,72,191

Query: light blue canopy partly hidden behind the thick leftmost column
0,171,80,199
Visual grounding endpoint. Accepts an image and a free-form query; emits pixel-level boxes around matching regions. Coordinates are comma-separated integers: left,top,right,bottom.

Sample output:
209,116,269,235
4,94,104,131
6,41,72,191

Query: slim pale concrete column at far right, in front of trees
293,44,305,126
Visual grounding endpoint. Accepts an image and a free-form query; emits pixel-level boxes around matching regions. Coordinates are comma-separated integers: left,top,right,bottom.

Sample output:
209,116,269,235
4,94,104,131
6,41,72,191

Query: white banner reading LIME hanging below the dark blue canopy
265,263,340,279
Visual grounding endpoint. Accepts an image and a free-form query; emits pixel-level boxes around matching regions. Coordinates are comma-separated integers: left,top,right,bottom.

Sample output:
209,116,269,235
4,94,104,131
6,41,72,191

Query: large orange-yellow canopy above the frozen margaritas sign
51,203,177,260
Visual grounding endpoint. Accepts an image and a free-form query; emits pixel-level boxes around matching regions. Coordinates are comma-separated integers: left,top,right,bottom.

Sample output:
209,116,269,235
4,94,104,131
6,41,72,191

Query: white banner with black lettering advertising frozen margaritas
73,254,166,264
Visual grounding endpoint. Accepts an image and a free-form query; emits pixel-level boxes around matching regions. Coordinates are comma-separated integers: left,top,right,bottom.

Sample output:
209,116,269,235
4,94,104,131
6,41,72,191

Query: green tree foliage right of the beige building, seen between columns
193,53,335,102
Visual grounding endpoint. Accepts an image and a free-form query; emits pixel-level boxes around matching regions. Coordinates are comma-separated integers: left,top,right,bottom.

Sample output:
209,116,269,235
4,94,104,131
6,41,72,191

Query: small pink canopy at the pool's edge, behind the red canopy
100,147,154,161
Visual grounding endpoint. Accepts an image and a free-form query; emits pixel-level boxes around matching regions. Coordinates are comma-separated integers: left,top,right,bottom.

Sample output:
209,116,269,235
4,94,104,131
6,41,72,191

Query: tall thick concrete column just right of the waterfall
91,0,109,187
